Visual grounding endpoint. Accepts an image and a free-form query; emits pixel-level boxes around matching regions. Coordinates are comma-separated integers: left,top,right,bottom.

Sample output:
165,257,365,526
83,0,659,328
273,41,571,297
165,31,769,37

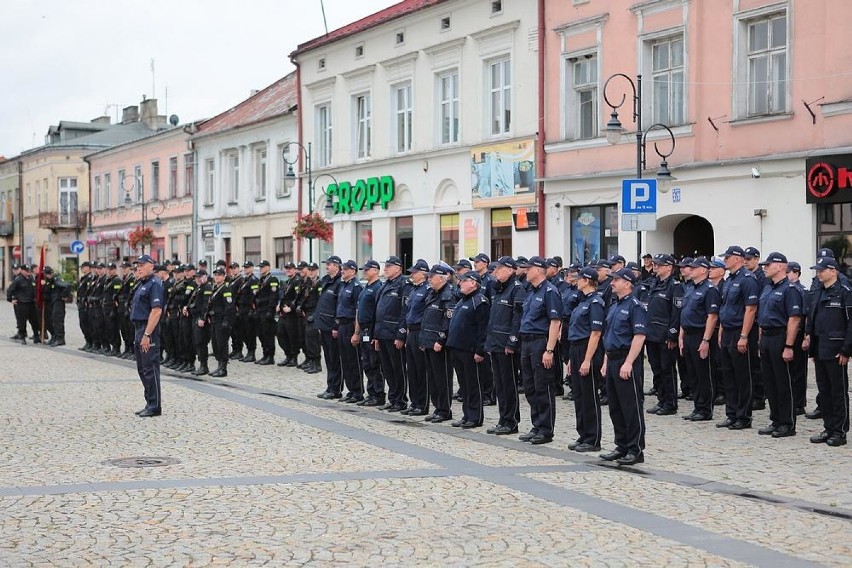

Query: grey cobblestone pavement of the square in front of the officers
0,304,852,568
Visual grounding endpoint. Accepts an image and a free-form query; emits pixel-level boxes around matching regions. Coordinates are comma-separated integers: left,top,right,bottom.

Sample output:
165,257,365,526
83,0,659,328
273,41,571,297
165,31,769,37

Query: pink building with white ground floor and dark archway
541,0,852,276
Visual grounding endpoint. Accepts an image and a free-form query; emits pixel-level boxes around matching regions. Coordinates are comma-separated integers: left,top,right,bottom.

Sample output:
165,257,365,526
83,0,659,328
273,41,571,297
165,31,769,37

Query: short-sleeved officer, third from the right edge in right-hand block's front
716,245,759,430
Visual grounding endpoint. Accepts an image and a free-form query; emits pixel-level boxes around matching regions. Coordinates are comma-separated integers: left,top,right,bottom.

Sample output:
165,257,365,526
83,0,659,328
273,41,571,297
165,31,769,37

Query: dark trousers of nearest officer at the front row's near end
606,349,645,455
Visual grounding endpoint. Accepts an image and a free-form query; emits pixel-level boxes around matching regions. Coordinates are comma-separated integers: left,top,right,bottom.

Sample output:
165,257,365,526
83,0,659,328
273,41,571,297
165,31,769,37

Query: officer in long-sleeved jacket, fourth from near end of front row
485,256,527,436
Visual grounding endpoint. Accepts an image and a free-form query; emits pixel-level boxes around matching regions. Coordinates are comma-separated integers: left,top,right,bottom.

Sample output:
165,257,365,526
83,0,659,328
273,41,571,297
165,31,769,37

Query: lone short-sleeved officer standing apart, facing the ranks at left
130,254,163,418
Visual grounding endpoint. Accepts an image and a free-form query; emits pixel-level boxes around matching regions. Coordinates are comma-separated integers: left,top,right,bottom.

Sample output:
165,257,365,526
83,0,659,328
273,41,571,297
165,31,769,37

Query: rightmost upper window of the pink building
747,14,787,116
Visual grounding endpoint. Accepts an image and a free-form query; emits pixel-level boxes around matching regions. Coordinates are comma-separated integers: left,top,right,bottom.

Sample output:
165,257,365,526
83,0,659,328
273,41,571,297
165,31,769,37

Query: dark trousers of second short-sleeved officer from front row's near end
569,339,603,446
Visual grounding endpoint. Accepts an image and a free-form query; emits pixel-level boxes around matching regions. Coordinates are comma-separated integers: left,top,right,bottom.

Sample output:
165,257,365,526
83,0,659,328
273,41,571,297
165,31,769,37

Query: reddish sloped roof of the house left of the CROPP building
195,71,298,137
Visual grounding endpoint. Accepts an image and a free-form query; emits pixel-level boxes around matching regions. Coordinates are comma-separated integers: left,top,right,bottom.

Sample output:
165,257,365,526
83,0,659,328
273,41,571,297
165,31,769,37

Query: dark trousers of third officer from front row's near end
521,335,556,437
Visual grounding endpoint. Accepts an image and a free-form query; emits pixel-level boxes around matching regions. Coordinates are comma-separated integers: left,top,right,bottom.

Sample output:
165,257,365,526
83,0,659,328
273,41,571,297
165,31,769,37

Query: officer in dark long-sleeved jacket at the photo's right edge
802,256,852,446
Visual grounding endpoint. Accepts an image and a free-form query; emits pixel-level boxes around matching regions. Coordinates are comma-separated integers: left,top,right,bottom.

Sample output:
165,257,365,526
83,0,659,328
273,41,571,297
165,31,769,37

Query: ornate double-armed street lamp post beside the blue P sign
603,73,675,262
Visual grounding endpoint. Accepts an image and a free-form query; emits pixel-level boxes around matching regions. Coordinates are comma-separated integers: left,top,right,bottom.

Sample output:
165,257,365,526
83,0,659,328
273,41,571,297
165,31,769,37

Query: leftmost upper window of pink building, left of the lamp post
565,54,598,139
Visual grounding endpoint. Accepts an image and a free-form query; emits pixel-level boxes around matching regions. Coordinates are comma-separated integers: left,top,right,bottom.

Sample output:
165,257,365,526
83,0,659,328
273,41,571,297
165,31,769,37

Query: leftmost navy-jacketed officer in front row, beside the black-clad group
314,255,343,400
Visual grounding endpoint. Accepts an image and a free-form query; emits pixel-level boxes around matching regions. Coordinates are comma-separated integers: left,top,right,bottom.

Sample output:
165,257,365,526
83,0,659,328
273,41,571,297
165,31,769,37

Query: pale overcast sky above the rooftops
0,0,399,157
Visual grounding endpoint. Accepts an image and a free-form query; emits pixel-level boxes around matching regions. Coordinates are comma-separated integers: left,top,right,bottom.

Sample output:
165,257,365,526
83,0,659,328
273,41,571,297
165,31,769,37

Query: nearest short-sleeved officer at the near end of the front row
601,268,648,465
